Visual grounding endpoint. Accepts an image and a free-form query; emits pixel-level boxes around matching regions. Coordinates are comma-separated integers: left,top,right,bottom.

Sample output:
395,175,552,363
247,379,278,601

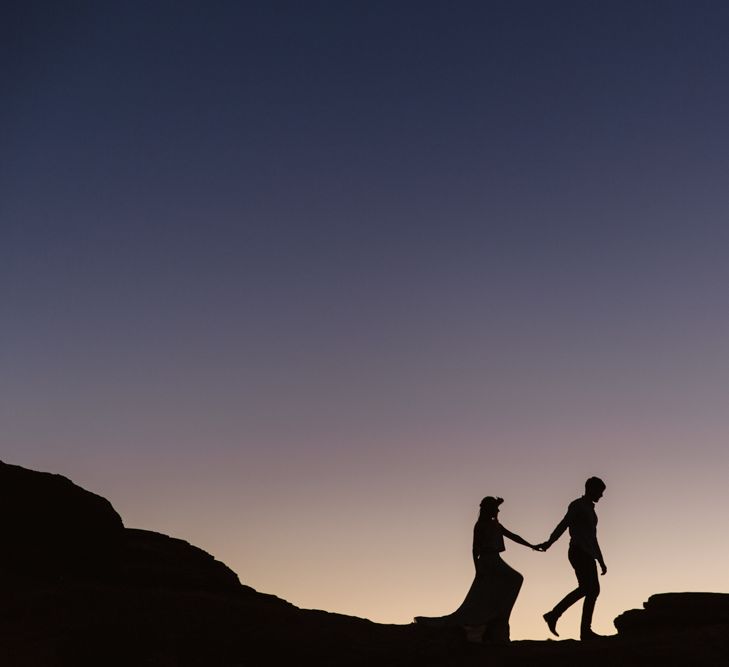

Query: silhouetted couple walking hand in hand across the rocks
415,477,607,642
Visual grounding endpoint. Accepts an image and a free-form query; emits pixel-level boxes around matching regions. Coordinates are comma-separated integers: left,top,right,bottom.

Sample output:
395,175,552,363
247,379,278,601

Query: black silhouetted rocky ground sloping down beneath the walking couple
0,462,729,667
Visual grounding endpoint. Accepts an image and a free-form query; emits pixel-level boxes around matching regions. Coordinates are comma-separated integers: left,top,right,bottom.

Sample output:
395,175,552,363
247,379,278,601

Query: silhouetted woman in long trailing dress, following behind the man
415,496,537,641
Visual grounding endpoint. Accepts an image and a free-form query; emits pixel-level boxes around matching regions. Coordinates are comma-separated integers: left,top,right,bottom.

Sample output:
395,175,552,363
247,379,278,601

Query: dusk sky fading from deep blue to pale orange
0,0,729,639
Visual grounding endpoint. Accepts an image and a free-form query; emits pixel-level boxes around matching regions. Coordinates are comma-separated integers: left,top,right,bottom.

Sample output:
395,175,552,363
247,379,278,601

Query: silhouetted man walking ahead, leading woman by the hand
538,477,607,640
